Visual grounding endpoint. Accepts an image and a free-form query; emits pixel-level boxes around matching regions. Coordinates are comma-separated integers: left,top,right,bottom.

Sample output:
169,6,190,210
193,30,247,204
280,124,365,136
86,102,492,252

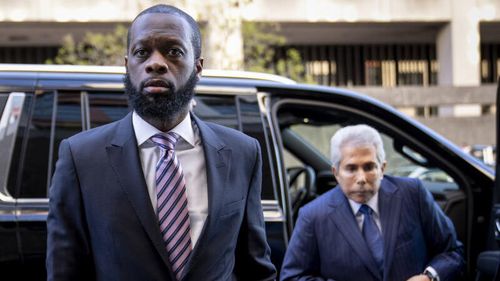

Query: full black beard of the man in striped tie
123,70,198,121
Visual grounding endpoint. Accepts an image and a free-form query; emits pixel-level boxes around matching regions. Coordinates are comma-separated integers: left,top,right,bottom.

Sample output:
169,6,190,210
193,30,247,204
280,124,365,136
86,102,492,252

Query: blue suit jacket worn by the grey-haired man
281,176,463,281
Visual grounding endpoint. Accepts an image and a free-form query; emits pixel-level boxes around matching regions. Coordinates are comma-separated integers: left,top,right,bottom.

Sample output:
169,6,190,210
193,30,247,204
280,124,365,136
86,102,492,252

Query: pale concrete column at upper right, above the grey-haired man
436,0,481,86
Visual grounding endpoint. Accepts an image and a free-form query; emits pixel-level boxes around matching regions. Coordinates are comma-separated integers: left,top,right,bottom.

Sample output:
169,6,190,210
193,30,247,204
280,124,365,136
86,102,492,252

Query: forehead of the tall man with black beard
130,13,191,44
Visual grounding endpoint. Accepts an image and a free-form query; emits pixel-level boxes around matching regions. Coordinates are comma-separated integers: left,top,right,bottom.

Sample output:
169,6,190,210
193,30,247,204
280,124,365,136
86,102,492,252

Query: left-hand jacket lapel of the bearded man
106,113,174,278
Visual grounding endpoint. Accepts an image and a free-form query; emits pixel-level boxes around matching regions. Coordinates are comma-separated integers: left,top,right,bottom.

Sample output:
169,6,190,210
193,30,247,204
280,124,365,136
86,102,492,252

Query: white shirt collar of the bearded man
132,111,195,147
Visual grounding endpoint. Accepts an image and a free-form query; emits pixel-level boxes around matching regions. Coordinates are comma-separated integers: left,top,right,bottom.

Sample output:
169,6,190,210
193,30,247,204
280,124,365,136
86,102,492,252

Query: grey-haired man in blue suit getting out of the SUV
280,125,464,281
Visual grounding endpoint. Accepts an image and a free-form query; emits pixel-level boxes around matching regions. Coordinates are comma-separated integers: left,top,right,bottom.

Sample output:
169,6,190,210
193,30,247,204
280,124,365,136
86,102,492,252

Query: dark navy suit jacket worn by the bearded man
47,114,275,281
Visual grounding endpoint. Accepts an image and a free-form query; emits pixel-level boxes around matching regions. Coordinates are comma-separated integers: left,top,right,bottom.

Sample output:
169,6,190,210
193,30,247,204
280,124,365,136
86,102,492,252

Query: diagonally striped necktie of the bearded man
151,132,191,280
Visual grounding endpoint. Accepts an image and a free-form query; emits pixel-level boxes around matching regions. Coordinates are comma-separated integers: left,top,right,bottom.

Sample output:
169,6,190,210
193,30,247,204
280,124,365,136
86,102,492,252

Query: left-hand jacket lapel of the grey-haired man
329,186,382,280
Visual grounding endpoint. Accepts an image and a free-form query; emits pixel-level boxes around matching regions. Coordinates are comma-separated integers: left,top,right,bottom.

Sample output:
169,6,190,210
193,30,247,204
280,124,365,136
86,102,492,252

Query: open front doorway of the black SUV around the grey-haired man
273,99,470,247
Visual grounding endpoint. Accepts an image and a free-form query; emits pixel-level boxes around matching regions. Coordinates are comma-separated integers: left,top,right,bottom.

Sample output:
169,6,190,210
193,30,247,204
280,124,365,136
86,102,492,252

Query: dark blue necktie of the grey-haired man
359,204,384,272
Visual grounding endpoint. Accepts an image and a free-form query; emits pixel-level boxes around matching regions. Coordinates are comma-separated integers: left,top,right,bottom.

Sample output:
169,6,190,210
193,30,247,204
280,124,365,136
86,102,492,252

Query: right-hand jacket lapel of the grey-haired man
378,179,401,272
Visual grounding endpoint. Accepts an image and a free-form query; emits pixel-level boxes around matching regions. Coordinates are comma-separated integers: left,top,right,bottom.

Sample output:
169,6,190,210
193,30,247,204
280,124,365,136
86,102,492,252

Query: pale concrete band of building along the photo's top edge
4,0,500,22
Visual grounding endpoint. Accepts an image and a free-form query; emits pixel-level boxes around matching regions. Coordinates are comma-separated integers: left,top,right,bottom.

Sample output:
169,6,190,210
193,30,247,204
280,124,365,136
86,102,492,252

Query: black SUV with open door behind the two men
0,64,500,280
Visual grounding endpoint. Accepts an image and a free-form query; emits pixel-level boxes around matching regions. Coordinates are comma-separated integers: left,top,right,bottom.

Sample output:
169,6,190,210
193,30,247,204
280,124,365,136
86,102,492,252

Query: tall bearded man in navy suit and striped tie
47,5,276,281
